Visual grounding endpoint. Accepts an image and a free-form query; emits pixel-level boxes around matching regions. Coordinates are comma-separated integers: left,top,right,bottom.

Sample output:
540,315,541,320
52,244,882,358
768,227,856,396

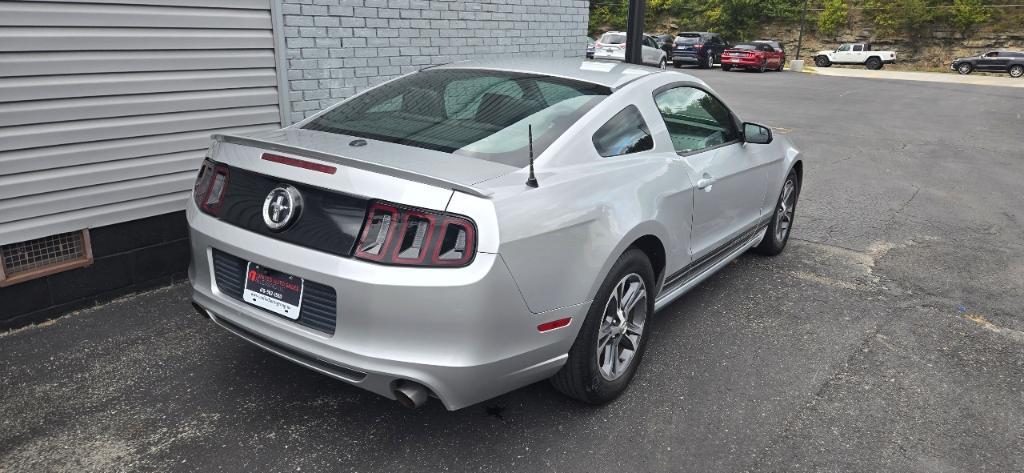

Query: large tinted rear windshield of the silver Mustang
303,70,611,167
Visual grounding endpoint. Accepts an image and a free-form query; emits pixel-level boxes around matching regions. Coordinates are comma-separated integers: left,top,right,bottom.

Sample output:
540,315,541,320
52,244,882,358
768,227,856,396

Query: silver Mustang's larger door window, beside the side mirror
654,87,739,153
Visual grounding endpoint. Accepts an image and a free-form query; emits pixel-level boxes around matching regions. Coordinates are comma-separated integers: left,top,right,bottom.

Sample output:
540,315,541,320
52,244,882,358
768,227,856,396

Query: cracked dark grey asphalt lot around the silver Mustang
0,69,1024,472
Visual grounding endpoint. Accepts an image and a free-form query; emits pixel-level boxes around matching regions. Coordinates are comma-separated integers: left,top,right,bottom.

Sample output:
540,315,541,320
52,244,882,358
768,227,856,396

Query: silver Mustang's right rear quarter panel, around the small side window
485,73,693,313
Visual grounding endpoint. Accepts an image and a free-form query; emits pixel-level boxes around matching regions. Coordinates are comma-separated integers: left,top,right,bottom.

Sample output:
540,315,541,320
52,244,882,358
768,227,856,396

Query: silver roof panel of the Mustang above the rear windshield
430,57,679,89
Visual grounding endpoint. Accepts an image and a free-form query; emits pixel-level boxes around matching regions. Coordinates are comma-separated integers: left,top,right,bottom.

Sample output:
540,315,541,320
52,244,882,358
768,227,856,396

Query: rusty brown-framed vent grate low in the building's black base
0,230,92,287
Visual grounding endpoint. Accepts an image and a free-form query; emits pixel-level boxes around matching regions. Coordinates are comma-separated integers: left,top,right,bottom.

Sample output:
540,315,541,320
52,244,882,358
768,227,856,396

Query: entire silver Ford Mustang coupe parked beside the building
187,59,803,410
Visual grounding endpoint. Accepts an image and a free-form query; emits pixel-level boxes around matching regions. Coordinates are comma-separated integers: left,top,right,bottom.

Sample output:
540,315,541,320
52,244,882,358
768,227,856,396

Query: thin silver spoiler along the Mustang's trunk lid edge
210,133,494,199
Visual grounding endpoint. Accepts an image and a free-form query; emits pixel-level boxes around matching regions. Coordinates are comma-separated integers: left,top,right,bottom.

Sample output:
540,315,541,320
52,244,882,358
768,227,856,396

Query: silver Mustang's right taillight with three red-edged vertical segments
355,202,476,266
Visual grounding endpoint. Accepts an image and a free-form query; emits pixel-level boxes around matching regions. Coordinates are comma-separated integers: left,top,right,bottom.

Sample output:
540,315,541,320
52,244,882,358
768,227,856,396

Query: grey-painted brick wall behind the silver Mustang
283,0,590,122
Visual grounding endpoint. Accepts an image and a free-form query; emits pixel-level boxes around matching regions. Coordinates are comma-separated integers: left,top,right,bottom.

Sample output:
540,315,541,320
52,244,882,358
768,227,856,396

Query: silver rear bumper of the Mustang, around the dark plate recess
187,205,588,410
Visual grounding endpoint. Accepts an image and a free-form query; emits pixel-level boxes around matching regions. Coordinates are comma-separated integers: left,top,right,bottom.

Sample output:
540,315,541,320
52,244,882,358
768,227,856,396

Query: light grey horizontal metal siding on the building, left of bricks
0,0,282,244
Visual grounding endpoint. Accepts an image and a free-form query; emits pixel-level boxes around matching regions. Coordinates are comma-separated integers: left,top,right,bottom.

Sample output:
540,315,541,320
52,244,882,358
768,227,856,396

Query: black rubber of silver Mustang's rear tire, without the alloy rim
551,248,654,404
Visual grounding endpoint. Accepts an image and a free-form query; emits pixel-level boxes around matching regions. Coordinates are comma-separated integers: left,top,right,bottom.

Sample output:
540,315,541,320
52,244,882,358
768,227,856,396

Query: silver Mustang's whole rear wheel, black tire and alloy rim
551,248,654,404
